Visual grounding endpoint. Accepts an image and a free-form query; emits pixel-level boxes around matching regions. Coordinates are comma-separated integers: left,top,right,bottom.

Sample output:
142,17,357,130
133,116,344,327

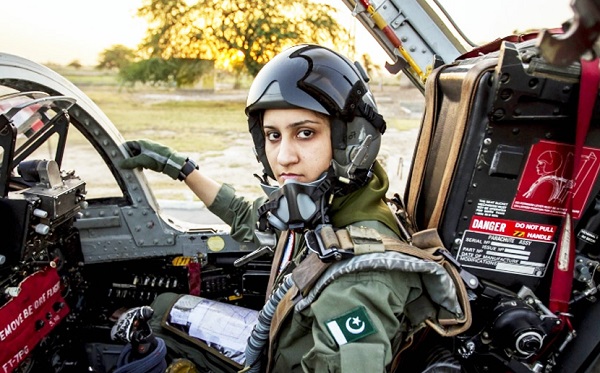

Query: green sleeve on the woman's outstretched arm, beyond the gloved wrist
208,184,266,242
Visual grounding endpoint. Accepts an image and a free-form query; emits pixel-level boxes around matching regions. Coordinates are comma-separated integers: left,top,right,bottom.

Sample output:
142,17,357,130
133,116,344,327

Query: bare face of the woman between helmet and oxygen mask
263,109,333,185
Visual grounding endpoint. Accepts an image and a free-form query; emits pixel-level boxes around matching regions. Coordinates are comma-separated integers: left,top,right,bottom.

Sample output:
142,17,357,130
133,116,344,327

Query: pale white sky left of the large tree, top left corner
0,0,146,65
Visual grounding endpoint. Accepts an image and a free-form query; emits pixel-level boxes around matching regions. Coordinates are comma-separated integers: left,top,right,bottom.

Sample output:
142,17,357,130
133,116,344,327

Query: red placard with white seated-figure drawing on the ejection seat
511,141,600,219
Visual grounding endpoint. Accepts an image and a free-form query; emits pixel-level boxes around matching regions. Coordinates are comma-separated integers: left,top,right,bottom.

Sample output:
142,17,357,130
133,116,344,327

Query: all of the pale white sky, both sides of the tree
0,0,573,65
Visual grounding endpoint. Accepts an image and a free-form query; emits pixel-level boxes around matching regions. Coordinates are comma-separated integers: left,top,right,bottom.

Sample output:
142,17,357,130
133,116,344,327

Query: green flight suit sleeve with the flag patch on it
302,271,421,373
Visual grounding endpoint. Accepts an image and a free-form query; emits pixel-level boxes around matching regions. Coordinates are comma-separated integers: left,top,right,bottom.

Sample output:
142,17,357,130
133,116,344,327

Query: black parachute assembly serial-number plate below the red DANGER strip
457,230,555,277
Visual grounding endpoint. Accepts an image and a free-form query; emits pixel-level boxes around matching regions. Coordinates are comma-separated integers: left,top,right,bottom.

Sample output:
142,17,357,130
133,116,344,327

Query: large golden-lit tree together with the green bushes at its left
97,0,352,87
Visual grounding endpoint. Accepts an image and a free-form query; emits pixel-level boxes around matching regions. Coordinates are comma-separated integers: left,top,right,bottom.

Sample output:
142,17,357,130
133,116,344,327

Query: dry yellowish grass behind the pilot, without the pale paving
57,68,419,146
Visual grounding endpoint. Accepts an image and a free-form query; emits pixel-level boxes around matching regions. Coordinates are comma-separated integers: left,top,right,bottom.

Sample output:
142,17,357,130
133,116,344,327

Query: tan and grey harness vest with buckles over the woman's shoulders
260,226,476,371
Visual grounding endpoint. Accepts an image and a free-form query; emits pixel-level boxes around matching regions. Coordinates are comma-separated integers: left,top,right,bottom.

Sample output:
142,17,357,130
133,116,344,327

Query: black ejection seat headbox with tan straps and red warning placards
405,40,600,291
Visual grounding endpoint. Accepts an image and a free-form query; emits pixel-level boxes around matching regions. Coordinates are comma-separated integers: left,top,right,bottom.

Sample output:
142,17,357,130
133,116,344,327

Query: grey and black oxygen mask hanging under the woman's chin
258,168,332,231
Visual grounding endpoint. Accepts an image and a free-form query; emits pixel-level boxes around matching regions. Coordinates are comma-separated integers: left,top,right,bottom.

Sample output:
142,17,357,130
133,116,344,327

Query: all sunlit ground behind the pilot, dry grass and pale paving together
55,68,423,201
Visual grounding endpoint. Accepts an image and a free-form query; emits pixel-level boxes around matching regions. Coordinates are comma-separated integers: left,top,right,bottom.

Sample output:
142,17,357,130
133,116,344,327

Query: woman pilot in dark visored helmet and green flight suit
122,45,422,372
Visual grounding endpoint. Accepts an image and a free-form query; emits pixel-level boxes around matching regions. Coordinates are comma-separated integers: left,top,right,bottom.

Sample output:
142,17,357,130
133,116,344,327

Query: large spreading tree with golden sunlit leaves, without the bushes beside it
138,0,348,76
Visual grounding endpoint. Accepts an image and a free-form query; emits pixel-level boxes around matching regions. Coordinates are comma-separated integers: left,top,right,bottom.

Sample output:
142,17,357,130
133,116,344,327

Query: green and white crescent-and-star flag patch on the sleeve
326,306,375,346
